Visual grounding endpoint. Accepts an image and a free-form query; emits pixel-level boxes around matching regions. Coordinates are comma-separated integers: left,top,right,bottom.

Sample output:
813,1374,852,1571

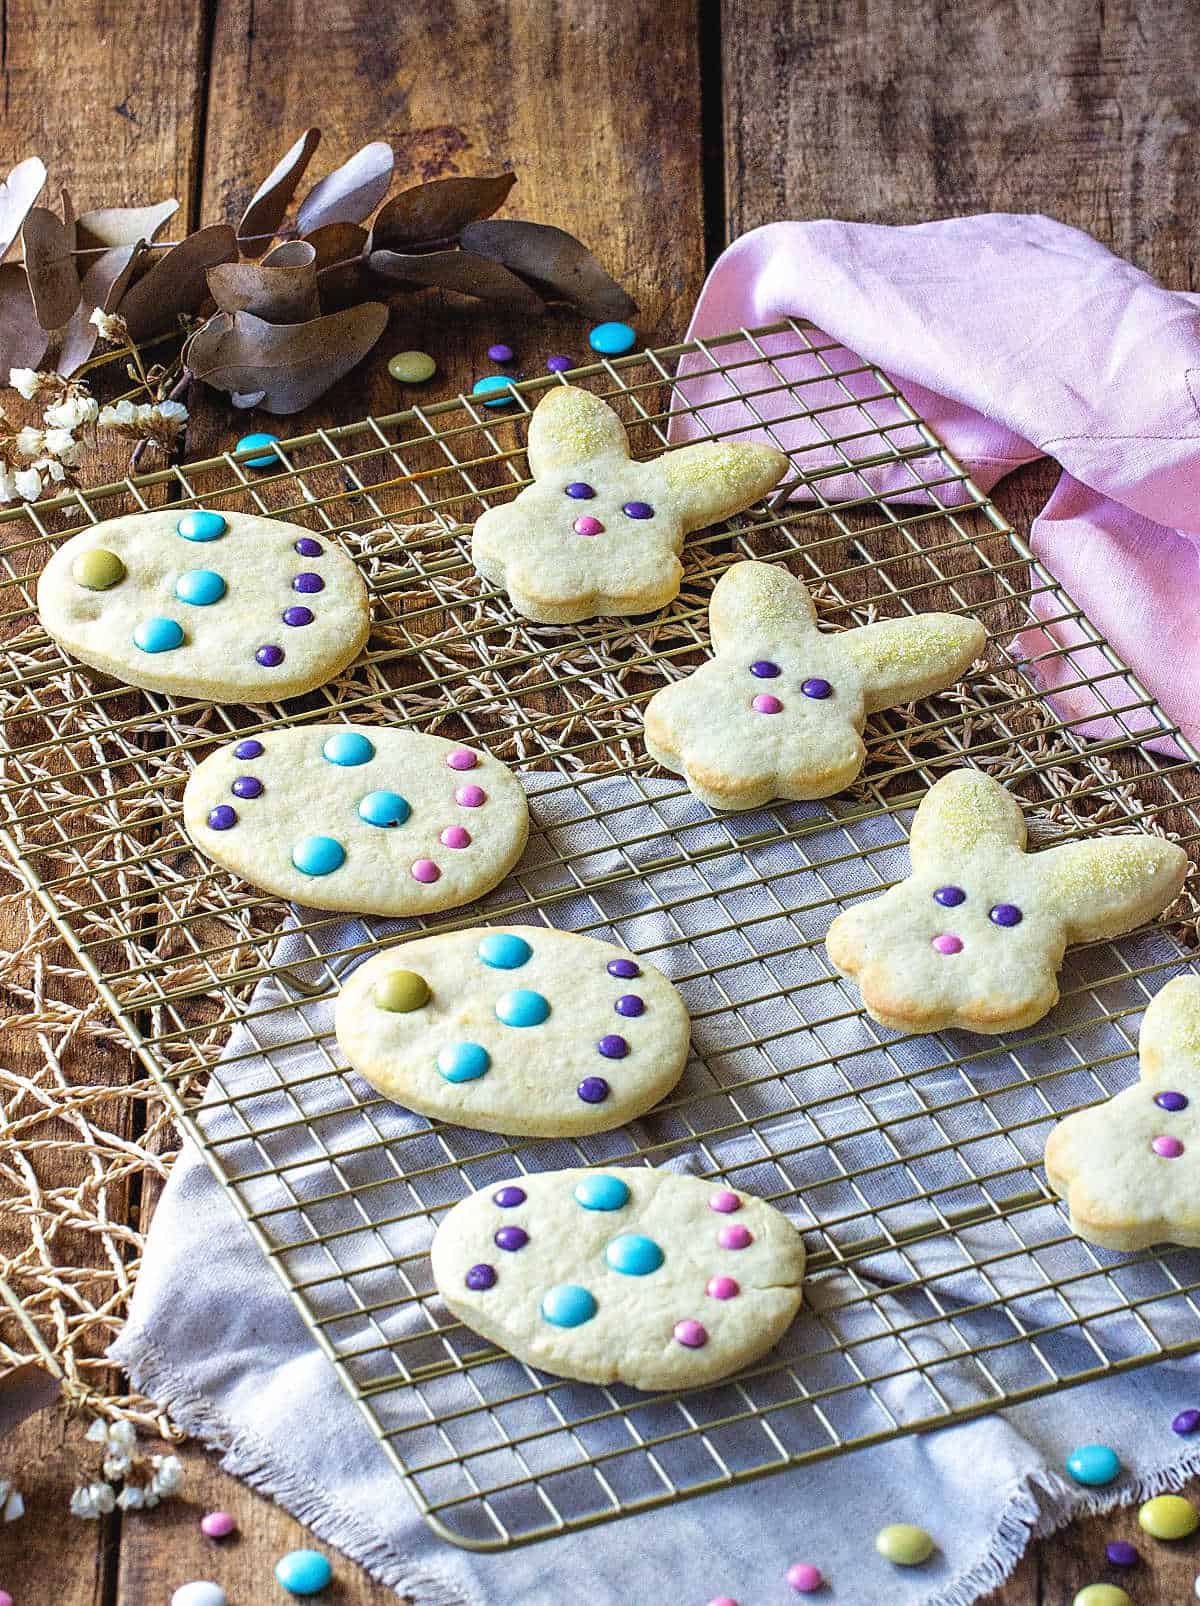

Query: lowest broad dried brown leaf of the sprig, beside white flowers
183,302,387,413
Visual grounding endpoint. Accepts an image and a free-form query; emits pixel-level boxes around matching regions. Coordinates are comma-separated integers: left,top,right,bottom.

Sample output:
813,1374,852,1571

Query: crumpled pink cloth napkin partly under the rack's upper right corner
676,214,1200,753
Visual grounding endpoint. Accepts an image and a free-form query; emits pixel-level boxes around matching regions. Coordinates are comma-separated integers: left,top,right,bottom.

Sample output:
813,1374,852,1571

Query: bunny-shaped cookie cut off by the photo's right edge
1046,976,1200,1249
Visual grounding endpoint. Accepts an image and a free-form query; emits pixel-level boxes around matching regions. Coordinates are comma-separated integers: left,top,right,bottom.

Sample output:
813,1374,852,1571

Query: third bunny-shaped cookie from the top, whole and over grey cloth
826,769,1187,1033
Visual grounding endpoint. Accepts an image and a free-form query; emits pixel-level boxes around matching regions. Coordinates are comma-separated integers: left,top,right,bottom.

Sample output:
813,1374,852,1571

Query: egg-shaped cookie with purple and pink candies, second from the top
183,724,529,915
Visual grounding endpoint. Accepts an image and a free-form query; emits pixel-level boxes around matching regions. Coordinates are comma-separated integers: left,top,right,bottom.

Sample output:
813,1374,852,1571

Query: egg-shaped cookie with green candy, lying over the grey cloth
336,925,688,1137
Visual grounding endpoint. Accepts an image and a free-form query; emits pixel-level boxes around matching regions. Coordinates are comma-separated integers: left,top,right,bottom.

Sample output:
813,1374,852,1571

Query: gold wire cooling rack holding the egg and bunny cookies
0,321,1200,1550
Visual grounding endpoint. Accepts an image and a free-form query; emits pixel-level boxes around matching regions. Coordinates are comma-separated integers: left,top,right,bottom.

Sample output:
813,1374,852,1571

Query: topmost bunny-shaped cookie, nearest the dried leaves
471,385,787,625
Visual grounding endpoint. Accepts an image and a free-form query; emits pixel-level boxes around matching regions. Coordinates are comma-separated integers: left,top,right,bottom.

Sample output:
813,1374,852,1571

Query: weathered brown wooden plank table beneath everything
0,0,1200,1606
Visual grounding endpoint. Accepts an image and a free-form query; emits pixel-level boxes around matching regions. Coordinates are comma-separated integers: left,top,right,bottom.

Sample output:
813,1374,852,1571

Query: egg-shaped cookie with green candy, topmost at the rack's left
37,507,371,703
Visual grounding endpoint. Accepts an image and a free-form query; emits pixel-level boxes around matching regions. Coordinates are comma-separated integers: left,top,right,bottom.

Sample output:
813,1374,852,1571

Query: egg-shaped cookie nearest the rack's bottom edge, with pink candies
432,1166,805,1389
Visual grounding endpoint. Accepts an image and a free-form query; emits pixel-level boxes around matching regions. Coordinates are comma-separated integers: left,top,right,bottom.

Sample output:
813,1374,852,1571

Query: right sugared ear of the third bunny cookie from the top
1033,835,1187,943
